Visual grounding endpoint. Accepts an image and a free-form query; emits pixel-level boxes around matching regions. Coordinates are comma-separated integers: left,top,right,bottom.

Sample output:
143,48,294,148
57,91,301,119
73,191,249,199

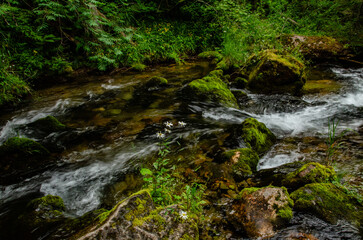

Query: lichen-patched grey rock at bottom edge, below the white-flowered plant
75,190,199,240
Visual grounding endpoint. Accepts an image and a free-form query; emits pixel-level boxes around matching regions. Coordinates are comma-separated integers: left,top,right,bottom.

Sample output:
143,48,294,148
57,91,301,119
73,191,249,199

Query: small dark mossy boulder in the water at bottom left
19,195,65,231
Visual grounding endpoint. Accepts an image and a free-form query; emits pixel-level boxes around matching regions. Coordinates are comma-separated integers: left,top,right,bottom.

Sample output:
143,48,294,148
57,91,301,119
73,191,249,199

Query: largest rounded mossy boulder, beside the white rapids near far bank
245,50,306,94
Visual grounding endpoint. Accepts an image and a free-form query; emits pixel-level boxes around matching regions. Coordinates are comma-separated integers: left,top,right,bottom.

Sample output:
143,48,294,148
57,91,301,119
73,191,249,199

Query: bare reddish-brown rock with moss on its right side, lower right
229,187,293,238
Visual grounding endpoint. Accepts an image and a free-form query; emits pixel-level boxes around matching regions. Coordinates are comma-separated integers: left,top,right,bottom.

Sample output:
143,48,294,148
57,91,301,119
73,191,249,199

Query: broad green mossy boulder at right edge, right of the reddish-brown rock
291,183,363,227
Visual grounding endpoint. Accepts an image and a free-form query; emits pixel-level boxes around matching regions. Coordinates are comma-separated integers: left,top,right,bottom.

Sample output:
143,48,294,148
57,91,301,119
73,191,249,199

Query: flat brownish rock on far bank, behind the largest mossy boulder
282,35,348,60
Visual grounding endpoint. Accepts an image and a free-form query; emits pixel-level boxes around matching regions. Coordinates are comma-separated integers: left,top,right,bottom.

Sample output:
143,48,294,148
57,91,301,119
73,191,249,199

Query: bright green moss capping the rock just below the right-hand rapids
241,118,276,154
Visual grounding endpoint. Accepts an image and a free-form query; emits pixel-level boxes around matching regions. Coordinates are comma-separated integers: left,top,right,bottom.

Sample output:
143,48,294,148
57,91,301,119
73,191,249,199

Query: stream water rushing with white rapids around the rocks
0,62,363,239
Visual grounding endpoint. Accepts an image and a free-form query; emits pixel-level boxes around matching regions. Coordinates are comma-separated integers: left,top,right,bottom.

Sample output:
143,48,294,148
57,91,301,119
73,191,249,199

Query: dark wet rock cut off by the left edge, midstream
0,137,51,184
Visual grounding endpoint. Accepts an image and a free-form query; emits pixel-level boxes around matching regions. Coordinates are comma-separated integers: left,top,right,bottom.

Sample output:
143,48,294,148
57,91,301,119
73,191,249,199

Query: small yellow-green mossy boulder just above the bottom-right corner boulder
282,162,336,189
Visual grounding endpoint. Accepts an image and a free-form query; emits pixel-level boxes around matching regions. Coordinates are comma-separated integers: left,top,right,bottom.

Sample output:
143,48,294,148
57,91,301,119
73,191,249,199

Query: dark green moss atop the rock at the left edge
0,137,49,157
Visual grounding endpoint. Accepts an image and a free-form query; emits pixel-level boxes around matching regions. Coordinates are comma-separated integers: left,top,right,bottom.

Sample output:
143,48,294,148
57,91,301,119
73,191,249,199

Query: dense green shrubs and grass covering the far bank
0,0,363,105
